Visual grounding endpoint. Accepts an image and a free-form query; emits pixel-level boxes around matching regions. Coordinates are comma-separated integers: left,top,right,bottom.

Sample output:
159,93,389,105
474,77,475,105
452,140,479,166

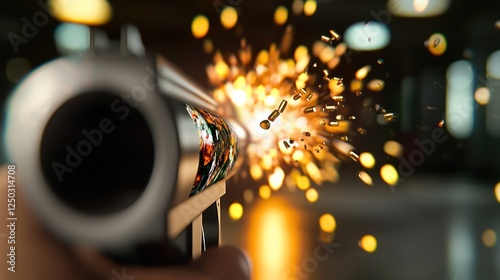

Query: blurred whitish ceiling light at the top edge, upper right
387,0,450,17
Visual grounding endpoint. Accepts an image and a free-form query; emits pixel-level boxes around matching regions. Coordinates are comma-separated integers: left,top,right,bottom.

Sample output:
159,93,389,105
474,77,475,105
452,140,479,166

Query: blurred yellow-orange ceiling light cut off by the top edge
49,0,113,25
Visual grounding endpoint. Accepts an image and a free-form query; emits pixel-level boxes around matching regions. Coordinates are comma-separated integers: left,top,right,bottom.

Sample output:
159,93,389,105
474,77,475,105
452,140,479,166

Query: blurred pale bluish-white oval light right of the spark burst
344,21,391,51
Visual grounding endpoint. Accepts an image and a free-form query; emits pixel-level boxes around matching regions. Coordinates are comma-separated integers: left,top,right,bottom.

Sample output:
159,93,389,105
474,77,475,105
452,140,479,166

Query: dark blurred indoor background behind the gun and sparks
0,0,500,280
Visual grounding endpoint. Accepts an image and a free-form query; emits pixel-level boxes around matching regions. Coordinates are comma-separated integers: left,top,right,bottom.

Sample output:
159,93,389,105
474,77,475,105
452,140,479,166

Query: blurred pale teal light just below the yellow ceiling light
54,23,90,55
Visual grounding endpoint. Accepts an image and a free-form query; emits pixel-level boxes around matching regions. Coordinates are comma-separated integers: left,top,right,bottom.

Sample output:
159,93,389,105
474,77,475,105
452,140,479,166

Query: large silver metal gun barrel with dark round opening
1,26,244,263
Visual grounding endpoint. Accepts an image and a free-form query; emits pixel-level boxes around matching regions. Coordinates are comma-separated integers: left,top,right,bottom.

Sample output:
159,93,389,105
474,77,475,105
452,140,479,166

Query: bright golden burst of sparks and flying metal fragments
201,10,397,195
